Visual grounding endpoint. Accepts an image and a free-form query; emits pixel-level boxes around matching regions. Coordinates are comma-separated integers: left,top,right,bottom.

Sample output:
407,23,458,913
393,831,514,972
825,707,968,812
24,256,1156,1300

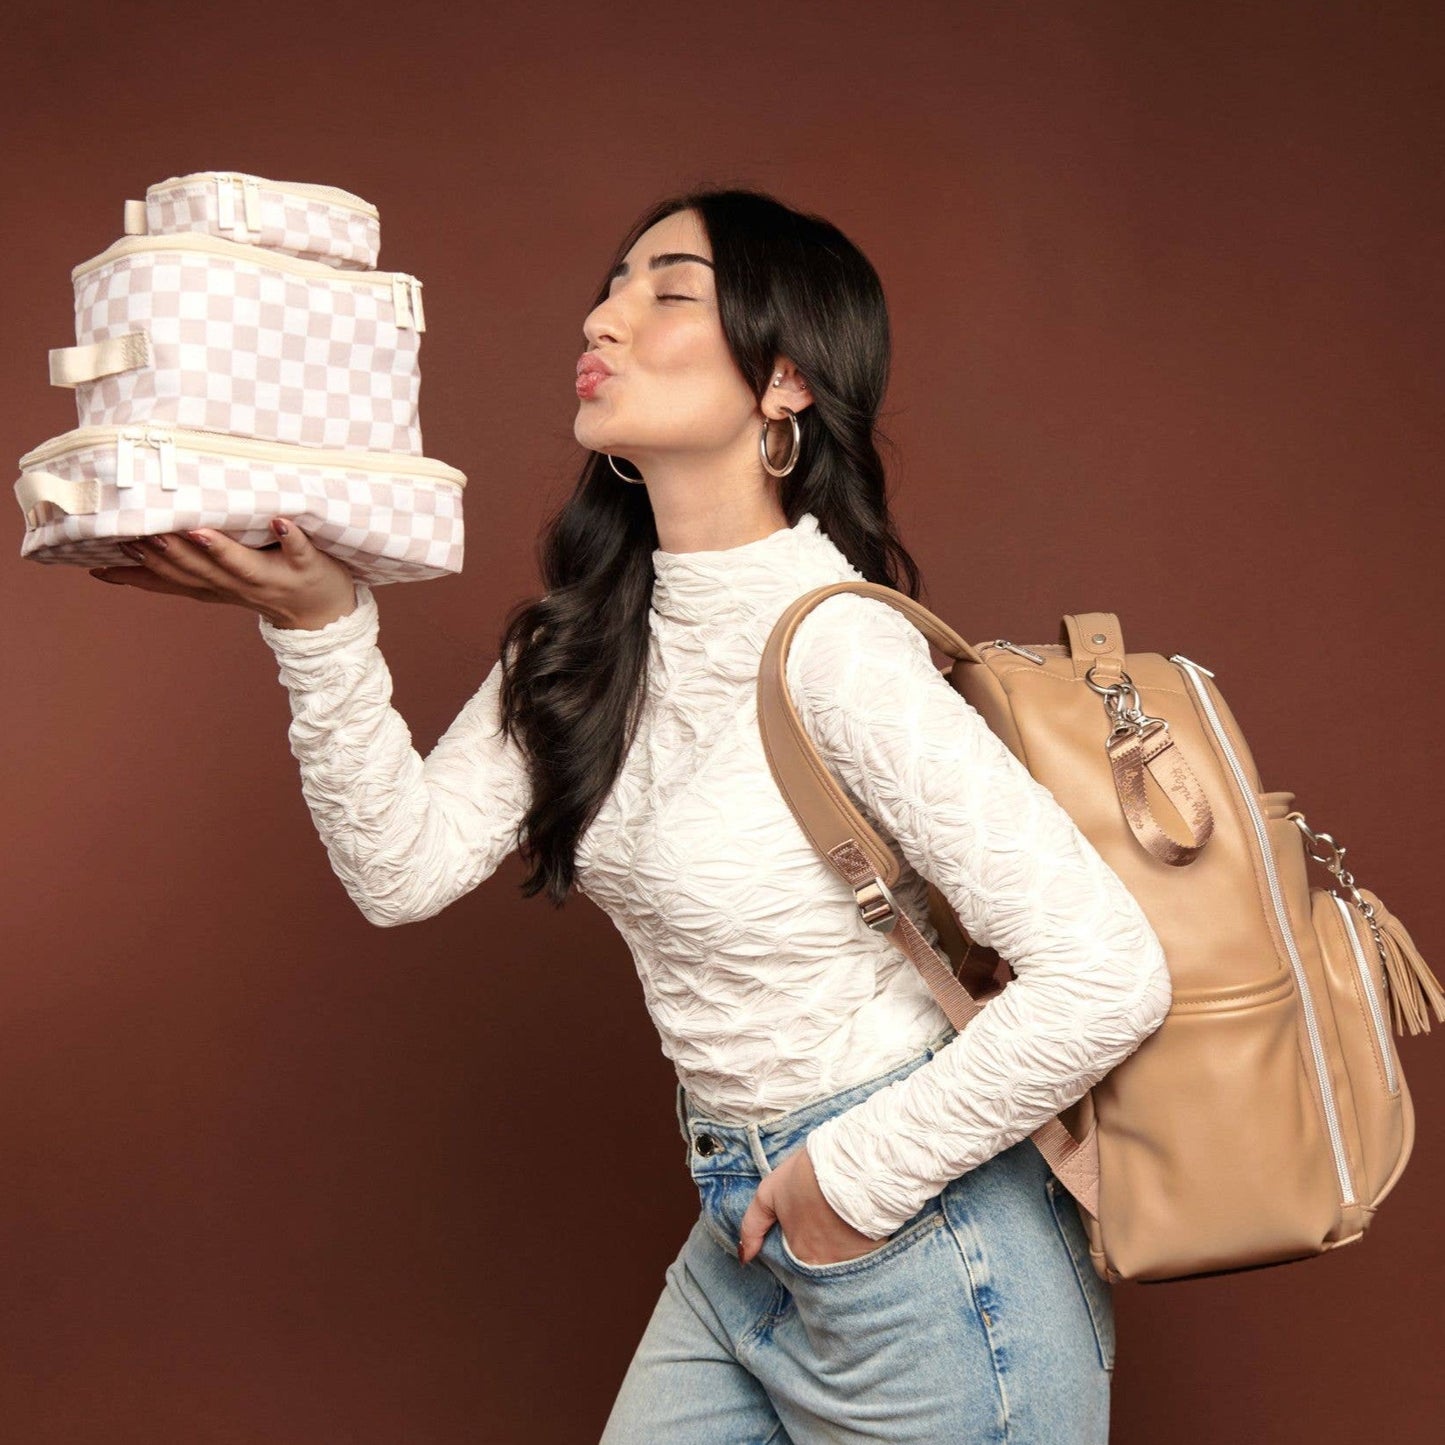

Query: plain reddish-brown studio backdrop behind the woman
0,0,1445,1445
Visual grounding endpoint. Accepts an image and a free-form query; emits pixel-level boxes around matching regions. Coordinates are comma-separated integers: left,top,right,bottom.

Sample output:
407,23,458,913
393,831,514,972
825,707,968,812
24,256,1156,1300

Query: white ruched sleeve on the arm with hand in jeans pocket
788,592,1172,1238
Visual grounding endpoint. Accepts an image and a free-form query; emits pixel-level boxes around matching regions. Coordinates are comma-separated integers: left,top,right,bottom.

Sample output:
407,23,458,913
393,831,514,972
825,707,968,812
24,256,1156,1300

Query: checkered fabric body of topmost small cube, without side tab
146,176,381,270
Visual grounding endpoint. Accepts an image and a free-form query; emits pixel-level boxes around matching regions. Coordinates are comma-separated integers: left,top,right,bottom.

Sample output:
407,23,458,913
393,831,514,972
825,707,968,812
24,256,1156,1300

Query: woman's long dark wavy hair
500,186,920,906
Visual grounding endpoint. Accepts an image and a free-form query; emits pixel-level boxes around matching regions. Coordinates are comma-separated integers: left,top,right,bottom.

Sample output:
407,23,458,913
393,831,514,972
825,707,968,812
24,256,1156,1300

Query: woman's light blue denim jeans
601,1027,1114,1445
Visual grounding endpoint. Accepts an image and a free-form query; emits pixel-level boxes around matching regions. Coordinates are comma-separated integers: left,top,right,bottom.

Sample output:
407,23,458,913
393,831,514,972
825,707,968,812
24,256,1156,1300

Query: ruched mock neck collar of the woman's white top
652,512,863,624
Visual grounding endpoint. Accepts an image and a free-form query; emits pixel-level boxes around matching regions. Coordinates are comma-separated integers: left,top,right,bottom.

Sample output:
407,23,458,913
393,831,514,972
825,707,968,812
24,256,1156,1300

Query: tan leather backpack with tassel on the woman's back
757,582,1445,1283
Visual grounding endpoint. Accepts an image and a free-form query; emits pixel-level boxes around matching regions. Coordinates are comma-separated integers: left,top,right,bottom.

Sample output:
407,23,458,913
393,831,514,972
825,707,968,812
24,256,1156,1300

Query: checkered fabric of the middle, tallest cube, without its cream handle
75,237,422,457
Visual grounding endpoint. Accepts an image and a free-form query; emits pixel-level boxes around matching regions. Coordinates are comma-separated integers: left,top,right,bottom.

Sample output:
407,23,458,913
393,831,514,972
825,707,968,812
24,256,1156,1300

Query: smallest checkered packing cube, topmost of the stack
126,171,381,270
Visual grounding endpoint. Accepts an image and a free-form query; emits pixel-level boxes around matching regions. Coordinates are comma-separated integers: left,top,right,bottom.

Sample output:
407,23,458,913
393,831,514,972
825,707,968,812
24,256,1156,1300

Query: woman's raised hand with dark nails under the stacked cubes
91,517,355,630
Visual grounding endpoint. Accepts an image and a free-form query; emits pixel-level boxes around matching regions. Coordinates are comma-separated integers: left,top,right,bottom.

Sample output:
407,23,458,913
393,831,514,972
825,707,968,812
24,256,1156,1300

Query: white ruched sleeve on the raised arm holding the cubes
259,579,530,928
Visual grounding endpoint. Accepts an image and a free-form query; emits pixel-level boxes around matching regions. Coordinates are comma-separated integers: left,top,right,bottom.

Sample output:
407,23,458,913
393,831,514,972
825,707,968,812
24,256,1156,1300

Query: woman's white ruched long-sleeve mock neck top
259,512,1170,1238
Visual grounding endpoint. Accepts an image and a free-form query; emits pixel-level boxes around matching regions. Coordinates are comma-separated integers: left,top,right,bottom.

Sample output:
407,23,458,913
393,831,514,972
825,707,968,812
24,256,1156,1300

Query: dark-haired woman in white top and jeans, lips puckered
84,189,1170,1445
